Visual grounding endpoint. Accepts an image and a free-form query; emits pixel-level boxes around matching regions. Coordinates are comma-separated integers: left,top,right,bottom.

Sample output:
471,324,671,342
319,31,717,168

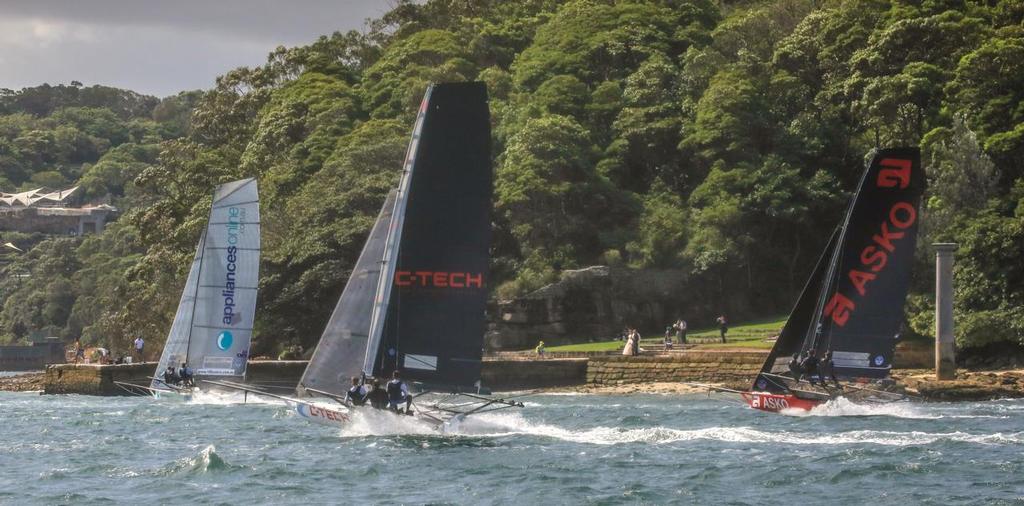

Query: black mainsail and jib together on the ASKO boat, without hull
755,147,925,389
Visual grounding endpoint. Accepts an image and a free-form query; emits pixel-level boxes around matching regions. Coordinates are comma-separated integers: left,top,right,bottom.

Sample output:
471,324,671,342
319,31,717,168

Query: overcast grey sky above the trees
0,0,392,96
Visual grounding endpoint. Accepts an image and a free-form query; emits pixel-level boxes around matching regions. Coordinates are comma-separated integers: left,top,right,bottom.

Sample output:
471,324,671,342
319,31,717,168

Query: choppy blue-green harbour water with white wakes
0,392,1024,505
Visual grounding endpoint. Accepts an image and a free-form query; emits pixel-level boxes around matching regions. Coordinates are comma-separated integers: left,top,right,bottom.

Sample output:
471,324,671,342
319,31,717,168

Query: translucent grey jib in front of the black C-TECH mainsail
299,191,396,395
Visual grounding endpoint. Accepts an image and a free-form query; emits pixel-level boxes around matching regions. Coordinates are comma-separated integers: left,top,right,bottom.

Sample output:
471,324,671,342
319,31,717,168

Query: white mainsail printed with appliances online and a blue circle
187,178,260,377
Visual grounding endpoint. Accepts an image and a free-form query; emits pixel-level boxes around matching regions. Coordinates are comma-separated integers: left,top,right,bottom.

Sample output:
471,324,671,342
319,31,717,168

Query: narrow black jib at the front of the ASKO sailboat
753,227,840,392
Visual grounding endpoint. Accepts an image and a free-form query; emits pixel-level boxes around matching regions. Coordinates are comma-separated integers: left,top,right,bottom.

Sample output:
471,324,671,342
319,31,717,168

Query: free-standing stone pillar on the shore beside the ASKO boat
932,243,956,380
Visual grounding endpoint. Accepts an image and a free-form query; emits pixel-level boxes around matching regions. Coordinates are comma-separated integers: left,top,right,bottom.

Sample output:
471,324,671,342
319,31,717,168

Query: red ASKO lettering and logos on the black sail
824,158,918,327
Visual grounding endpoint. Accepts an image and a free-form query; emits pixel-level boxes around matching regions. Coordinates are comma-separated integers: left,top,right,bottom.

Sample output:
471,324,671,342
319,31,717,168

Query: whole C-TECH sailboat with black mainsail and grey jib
212,83,522,425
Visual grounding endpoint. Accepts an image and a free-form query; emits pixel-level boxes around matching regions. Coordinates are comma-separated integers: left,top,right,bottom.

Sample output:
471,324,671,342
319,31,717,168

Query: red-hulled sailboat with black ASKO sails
737,147,926,412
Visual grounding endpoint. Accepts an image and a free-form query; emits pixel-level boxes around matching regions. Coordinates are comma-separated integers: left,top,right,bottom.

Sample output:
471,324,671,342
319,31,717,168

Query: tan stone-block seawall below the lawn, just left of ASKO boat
587,351,767,385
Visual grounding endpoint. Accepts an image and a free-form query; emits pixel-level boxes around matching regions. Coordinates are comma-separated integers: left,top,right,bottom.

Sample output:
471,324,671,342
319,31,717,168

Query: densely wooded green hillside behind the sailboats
0,0,1024,352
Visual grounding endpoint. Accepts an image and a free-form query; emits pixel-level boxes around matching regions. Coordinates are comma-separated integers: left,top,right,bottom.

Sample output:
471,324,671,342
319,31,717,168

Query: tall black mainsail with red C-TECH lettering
368,83,493,387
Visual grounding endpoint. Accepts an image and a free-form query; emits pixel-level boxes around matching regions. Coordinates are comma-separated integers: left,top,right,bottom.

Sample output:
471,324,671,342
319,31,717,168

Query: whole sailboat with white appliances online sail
120,178,260,396
